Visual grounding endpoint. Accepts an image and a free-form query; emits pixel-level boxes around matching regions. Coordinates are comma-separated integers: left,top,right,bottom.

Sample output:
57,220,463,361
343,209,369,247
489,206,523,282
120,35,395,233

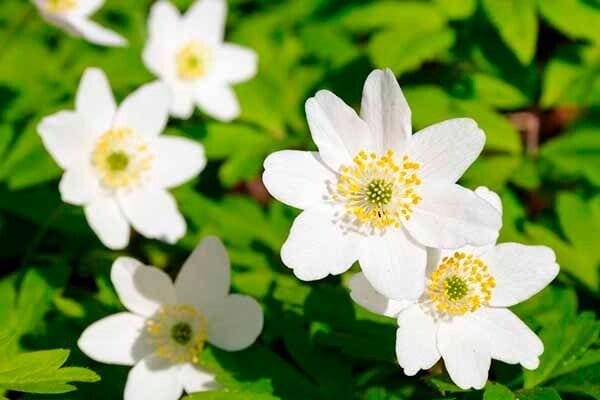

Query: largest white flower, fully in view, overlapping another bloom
263,70,501,298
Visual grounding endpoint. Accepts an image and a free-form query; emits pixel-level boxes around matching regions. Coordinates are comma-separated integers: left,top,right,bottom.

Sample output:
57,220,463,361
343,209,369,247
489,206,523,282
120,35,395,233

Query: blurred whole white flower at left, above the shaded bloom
38,68,206,249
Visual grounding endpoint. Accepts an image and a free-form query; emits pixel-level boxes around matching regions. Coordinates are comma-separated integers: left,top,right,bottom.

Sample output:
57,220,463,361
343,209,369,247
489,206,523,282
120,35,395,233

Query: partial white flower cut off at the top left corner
33,0,127,46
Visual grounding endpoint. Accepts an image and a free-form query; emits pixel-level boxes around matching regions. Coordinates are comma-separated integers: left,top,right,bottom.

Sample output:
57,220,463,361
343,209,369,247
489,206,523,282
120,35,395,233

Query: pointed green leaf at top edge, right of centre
483,0,538,65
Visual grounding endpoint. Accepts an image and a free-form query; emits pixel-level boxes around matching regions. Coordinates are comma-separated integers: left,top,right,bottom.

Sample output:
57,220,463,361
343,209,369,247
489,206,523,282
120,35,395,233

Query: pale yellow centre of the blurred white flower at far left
92,128,153,189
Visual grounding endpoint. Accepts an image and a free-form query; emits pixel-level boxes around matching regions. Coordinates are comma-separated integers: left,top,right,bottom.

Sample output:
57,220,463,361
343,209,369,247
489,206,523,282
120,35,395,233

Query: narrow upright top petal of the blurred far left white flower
75,68,117,138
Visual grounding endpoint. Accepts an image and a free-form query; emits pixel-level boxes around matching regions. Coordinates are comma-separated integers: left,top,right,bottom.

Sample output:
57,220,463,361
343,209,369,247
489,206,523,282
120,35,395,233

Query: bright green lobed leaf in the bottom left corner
0,350,100,393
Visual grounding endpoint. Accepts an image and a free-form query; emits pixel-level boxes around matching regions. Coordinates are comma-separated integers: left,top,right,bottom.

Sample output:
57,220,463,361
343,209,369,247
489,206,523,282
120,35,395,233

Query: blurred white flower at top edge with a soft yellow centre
143,0,257,121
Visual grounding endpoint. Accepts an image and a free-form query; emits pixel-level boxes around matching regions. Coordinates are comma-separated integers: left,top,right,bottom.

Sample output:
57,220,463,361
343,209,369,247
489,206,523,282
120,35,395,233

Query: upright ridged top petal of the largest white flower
360,69,412,154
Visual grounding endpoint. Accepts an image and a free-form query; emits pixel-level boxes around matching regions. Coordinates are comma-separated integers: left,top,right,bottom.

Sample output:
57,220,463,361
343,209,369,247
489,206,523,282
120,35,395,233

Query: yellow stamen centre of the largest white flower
332,150,421,229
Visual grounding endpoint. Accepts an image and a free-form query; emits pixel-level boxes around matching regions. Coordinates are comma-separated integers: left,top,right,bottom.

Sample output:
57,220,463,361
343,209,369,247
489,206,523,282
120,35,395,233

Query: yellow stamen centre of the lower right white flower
427,251,496,315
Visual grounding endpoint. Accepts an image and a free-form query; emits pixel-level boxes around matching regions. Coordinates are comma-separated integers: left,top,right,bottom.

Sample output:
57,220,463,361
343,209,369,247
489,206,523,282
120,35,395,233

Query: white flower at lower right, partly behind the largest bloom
350,188,559,389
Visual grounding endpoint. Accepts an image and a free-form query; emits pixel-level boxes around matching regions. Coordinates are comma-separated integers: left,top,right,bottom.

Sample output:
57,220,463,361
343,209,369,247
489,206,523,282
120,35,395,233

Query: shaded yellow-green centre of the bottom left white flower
146,305,206,363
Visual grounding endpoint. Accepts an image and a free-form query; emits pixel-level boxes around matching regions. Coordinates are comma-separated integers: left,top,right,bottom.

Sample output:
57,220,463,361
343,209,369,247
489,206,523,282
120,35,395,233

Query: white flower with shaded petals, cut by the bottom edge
78,237,263,400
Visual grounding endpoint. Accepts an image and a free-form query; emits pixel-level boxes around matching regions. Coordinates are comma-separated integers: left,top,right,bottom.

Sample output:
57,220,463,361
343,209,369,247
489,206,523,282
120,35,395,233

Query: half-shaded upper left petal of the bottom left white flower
110,257,176,317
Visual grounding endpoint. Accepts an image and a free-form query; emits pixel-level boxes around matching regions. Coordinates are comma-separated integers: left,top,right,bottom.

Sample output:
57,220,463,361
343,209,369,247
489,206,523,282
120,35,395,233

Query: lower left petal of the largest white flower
281,206,361,281
